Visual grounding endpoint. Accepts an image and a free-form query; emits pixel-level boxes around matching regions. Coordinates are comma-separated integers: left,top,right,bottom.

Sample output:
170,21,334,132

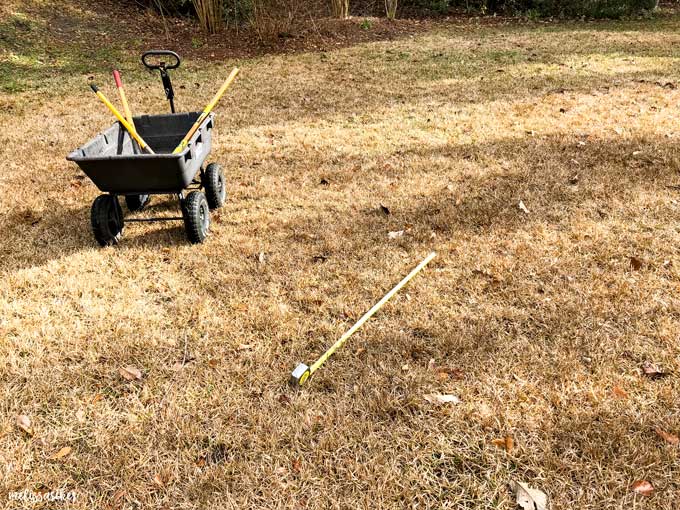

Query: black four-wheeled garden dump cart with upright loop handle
67,50,226,246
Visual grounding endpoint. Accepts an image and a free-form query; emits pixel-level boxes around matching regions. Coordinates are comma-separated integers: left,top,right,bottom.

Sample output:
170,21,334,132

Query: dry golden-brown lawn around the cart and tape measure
0,1,680,509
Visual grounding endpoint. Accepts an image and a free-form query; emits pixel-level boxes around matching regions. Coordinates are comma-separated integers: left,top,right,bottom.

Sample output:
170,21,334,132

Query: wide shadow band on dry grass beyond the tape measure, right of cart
278,131,680,251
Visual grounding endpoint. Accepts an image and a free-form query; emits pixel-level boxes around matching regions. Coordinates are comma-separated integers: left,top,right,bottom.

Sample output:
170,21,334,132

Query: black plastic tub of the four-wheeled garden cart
66,112,214,195
